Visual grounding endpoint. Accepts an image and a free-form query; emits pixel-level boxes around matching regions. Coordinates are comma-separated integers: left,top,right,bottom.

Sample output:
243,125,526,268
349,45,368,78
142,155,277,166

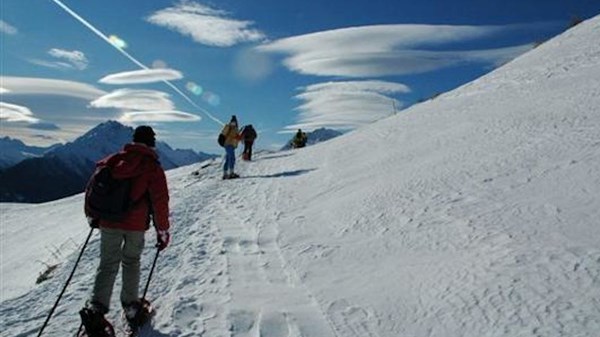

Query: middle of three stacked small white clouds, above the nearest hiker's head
90,89,175,111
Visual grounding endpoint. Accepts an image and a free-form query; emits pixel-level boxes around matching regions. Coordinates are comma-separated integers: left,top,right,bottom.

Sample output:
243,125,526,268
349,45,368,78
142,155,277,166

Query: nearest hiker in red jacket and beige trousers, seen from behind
86,126,170,330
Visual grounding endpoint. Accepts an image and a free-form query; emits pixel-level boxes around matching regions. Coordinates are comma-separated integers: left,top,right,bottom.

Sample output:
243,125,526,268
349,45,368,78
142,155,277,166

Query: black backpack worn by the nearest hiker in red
84,166,133,222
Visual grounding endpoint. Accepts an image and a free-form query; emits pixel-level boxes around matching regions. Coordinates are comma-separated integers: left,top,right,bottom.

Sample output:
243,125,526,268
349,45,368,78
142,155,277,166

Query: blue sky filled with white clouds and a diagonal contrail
0,0,600,152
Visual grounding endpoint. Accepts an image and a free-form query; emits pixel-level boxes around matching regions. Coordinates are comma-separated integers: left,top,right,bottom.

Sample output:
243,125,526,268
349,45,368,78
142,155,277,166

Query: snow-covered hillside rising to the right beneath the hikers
0,17,600,337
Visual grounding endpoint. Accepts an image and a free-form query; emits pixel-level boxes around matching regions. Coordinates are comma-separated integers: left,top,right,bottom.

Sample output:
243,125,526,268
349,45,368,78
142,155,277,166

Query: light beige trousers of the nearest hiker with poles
92,228,144,309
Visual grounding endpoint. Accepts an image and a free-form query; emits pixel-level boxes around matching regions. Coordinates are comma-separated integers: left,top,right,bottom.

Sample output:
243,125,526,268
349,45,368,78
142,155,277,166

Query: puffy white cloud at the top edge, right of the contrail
147,1,265,47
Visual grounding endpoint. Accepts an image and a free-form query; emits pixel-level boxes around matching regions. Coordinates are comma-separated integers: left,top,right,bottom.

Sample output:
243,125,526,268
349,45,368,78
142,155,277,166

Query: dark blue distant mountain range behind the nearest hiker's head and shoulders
0,121,218,203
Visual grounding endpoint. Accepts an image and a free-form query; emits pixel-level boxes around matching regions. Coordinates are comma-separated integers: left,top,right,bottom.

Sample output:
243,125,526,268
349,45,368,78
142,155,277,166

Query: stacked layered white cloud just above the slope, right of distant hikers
282,80,410,133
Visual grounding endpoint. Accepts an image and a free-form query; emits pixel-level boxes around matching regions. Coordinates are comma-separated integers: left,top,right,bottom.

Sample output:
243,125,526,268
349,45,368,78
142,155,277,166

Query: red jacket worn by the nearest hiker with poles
96,143,170,232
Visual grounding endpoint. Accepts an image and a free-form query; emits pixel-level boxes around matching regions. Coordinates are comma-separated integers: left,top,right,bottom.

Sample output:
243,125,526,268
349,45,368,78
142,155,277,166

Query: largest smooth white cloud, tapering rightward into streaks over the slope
257,24,547,78
